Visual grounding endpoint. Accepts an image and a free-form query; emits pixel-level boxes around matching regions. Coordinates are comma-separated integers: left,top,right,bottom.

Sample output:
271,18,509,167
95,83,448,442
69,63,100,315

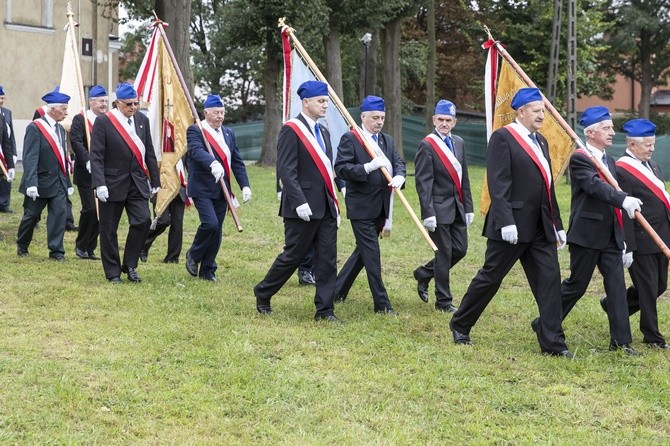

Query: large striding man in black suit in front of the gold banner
449,88,573,358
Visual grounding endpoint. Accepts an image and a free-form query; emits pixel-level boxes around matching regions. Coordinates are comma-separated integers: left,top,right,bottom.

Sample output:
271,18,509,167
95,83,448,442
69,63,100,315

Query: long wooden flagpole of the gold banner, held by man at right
486,29,670,259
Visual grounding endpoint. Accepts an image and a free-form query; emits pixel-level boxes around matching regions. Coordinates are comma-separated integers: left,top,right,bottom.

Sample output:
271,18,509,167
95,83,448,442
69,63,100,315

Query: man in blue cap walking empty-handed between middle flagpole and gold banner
414,99,475,313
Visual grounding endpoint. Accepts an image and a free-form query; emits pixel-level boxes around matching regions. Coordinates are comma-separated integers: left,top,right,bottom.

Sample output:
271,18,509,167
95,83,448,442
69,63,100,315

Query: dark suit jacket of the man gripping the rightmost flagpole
568,152,630,250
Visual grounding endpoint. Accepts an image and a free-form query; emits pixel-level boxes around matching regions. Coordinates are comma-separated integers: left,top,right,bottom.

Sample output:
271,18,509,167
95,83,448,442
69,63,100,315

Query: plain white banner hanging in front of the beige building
60,4,86,131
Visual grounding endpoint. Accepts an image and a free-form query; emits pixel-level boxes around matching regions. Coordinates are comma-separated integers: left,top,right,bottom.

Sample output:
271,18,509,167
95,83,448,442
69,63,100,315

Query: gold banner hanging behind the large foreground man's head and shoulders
480,59,573,214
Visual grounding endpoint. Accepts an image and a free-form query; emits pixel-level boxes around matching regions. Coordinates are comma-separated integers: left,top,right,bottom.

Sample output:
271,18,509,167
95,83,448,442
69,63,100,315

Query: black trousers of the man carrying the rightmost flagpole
561,242,633,345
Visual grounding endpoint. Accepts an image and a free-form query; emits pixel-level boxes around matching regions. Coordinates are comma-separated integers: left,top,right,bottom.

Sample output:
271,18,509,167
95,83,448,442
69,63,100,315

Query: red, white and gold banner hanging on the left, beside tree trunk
135,27,195,218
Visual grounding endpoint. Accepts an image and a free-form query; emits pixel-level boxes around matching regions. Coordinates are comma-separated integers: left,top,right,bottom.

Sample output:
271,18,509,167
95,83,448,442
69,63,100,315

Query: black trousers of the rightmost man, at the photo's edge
624,252,668,343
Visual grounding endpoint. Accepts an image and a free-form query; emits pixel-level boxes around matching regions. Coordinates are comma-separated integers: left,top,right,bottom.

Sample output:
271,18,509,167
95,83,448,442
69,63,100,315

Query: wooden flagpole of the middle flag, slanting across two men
279,18,437,251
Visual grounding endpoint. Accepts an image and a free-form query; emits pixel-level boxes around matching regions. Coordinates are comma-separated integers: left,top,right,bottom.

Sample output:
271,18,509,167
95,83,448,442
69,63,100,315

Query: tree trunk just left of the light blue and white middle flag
258,30,282,166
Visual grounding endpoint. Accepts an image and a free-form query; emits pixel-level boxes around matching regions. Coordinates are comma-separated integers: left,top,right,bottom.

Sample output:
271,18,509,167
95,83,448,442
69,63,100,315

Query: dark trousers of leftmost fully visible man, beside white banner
16,187,67,254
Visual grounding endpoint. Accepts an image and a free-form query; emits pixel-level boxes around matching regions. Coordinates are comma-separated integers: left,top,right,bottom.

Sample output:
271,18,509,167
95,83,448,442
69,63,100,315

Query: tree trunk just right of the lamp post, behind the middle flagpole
381,18,404,158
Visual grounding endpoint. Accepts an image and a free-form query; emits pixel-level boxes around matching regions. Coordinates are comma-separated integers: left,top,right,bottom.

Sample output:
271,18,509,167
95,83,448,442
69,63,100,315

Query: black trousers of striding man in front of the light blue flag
254,216,337,316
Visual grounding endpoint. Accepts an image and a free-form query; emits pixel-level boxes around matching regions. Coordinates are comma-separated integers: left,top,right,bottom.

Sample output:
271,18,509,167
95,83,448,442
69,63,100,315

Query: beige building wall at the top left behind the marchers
0,0,120,157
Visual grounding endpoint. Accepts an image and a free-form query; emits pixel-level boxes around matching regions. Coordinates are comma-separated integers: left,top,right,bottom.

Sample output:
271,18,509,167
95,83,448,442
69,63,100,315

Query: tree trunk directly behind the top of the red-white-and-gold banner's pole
154,0,194,95
